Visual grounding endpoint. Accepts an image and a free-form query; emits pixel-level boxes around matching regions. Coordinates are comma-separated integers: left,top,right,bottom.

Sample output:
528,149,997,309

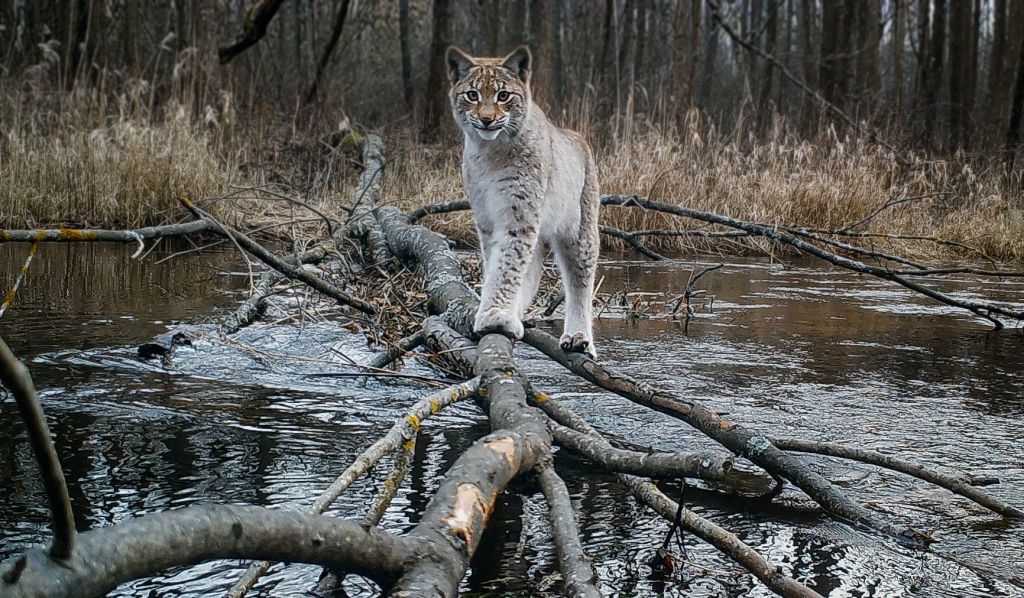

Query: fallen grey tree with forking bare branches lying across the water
0,133,1020,598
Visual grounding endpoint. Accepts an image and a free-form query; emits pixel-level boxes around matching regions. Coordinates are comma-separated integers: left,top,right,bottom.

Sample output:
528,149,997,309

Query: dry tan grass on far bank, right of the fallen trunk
386,112,1024,260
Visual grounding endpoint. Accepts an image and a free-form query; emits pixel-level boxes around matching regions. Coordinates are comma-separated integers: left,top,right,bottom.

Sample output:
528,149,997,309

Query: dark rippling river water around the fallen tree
0,246,1024,597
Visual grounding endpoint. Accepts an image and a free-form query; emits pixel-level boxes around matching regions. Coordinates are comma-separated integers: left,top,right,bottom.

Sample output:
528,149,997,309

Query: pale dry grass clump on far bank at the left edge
0,85,247,226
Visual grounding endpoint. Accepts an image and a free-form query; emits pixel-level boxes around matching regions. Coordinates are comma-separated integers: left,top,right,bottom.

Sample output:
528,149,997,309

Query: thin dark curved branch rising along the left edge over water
0,338,77,560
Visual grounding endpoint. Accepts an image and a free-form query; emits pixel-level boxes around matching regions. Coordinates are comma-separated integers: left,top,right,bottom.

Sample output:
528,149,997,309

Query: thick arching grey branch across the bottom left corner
0,505,416,598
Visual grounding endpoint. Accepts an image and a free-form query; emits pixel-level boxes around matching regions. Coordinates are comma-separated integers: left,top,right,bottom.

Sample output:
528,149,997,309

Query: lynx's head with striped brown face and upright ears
446,46,532,141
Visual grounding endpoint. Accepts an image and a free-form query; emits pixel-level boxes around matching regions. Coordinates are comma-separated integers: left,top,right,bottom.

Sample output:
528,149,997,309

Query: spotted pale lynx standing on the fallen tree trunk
446,46,600,357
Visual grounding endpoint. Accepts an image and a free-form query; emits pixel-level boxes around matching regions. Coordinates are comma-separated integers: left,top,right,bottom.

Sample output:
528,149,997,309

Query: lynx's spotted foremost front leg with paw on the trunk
473,226,538,339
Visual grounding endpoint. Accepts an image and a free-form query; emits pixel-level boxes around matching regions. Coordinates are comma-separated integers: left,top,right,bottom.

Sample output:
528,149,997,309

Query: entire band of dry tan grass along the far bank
0,77,1024,260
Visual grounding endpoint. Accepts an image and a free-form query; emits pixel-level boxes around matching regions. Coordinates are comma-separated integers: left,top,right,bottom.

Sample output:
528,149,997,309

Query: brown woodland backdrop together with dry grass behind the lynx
0,0,1024,259
